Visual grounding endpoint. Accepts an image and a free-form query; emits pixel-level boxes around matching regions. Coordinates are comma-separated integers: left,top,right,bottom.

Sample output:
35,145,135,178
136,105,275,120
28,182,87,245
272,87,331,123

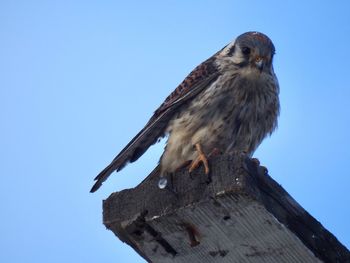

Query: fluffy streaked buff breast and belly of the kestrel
161,74,277,174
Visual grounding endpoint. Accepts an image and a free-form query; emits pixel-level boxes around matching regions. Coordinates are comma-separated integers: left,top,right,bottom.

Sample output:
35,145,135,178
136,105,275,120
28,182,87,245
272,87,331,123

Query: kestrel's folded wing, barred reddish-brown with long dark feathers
90,57,219,192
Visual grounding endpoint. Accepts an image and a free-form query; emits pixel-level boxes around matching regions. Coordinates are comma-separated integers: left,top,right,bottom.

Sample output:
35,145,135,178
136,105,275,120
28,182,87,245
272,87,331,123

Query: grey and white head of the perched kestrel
219,32,275,72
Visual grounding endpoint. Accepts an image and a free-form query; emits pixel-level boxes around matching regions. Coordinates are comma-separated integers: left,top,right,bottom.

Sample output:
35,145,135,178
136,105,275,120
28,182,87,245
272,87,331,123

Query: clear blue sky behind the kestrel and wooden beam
0,0,350,263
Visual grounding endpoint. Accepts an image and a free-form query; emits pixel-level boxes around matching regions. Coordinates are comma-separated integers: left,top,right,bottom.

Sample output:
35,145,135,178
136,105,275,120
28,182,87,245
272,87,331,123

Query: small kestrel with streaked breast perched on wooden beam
90,31,280,192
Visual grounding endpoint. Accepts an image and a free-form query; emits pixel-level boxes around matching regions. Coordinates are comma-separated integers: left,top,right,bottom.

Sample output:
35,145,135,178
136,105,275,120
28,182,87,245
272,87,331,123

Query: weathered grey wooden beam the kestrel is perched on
103,155,350,263
